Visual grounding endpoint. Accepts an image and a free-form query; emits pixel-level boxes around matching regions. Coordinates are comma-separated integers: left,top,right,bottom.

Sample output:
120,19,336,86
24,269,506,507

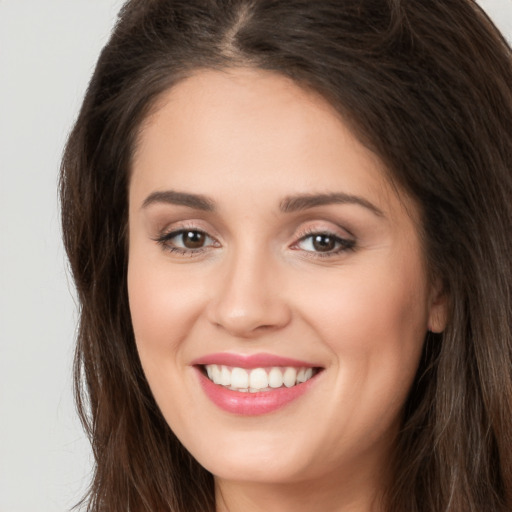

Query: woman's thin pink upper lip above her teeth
191,352,319,369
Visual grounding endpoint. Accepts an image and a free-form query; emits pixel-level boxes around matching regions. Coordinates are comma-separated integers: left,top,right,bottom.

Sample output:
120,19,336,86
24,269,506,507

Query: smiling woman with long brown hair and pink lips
61,0,512,512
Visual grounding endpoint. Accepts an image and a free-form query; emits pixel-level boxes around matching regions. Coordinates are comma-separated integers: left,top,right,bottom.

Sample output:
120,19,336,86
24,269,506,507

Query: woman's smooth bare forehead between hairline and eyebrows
132,69,412,221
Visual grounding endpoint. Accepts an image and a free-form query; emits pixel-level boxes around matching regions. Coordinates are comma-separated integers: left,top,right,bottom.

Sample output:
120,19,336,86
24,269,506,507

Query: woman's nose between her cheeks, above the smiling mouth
208,243,291,338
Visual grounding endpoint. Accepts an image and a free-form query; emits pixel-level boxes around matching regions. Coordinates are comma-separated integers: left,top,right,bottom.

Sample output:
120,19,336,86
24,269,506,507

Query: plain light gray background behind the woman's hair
0,0,512,512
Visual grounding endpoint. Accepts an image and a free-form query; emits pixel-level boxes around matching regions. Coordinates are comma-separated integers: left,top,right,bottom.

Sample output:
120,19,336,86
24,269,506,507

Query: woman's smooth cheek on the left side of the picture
128,247,208,430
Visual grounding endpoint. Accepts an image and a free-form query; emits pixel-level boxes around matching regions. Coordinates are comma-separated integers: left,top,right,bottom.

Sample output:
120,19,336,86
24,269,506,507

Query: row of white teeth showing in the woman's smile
205,364,314,393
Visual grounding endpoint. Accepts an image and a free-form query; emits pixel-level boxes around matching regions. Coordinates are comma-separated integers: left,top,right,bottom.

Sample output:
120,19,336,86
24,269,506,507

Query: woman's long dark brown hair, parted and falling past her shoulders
61,0,512,512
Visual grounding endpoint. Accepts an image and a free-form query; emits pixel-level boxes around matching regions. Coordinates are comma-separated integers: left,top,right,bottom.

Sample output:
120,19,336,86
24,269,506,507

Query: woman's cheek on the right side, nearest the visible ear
297,256,428,416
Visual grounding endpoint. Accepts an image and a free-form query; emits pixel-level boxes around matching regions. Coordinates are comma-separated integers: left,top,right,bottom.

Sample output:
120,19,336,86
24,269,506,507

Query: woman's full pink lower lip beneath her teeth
197,368,318,416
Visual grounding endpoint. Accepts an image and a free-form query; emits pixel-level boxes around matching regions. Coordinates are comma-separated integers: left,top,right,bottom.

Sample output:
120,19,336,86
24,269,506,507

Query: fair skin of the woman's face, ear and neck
128,69,446,512
